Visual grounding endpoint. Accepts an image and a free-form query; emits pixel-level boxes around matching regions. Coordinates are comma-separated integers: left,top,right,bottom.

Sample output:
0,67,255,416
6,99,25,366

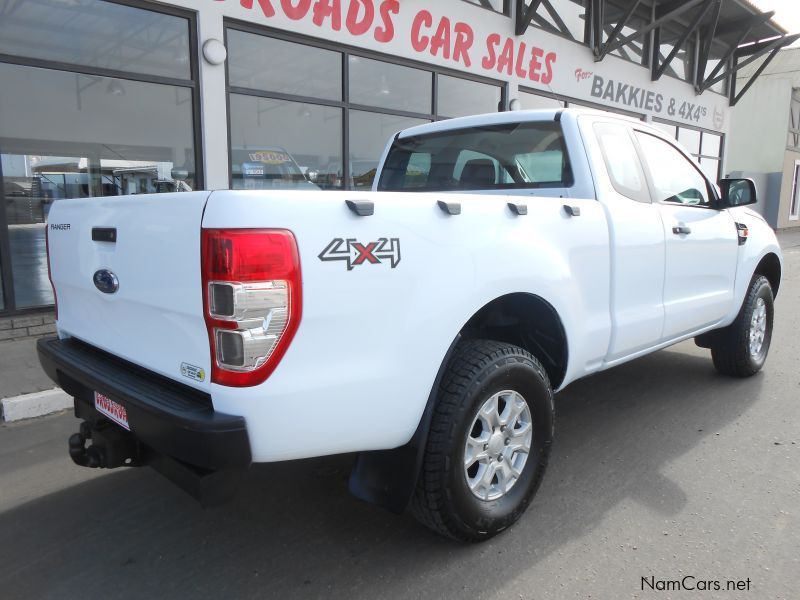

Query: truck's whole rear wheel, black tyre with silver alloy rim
411,340,553,542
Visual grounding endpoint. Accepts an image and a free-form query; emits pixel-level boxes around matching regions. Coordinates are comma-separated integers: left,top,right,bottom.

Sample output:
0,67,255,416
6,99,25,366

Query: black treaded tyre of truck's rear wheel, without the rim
411,340,554,542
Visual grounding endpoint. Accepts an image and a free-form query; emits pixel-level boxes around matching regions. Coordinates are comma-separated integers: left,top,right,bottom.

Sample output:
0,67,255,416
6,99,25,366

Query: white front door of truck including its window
635,130,739,341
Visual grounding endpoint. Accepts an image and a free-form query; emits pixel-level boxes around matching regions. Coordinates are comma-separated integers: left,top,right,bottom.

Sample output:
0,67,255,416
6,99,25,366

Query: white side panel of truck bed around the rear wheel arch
203,191,611,461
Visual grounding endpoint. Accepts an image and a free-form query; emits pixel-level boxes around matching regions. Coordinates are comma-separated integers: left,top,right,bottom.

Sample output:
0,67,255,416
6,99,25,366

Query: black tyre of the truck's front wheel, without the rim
711,274,774,377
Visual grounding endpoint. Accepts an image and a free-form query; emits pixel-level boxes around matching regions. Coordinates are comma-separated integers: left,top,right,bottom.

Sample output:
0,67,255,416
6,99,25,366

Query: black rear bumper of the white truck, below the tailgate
37,338,252,470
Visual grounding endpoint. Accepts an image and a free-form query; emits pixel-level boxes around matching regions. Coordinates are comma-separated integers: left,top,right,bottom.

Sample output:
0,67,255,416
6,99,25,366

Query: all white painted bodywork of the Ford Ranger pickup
49,111,781,462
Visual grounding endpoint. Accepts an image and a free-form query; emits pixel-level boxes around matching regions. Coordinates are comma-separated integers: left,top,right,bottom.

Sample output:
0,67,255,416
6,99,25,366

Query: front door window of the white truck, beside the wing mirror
636,131,710,206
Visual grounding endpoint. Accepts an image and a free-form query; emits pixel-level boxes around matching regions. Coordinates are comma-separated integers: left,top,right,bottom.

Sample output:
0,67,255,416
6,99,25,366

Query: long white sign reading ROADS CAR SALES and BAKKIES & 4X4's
209,0,728,130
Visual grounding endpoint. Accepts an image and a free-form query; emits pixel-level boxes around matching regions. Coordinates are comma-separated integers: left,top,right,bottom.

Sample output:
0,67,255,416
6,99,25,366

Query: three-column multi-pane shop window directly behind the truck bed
226,24,502,195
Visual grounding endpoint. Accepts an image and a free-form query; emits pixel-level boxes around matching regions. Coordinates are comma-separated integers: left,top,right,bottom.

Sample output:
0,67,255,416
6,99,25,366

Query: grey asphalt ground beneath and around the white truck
0,236,800,600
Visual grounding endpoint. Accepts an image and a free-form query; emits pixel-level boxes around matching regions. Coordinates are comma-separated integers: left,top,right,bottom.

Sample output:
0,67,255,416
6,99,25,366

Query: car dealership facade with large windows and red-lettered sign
0,0,787,316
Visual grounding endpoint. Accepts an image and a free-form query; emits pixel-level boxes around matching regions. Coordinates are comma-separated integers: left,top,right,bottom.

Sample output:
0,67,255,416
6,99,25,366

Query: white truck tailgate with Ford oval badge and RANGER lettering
47,192,210,390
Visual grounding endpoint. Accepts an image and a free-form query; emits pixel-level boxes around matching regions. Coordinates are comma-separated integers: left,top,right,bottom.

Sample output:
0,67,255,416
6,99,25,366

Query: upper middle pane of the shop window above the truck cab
348,55,433,115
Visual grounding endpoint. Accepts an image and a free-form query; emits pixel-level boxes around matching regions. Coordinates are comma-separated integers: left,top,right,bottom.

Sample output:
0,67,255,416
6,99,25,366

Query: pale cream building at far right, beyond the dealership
727,48,800,229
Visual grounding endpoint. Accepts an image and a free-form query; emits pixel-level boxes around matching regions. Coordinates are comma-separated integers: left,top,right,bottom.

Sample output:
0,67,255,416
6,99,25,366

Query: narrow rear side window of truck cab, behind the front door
594,123,650,203
